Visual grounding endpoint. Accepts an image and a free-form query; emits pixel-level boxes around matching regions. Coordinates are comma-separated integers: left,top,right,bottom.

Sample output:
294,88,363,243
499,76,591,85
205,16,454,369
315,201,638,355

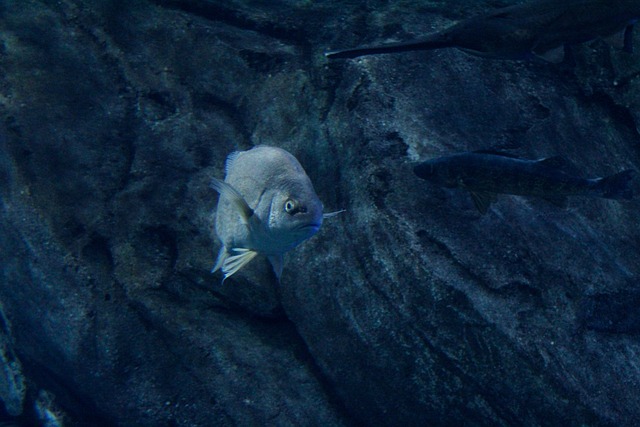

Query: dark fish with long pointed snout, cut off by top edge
325,0,640,62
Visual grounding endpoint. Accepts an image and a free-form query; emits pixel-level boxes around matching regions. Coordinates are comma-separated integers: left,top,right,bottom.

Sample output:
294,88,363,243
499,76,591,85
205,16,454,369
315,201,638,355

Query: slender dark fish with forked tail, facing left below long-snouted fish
413,151,635,214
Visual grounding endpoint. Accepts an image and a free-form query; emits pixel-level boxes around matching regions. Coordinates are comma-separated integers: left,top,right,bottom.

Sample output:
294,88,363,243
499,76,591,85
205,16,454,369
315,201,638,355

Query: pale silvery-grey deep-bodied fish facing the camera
212,145,339,281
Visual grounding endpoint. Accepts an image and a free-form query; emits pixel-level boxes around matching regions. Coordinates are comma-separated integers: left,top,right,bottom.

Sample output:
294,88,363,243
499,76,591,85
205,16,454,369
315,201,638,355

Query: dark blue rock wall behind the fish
0,0,640,426
